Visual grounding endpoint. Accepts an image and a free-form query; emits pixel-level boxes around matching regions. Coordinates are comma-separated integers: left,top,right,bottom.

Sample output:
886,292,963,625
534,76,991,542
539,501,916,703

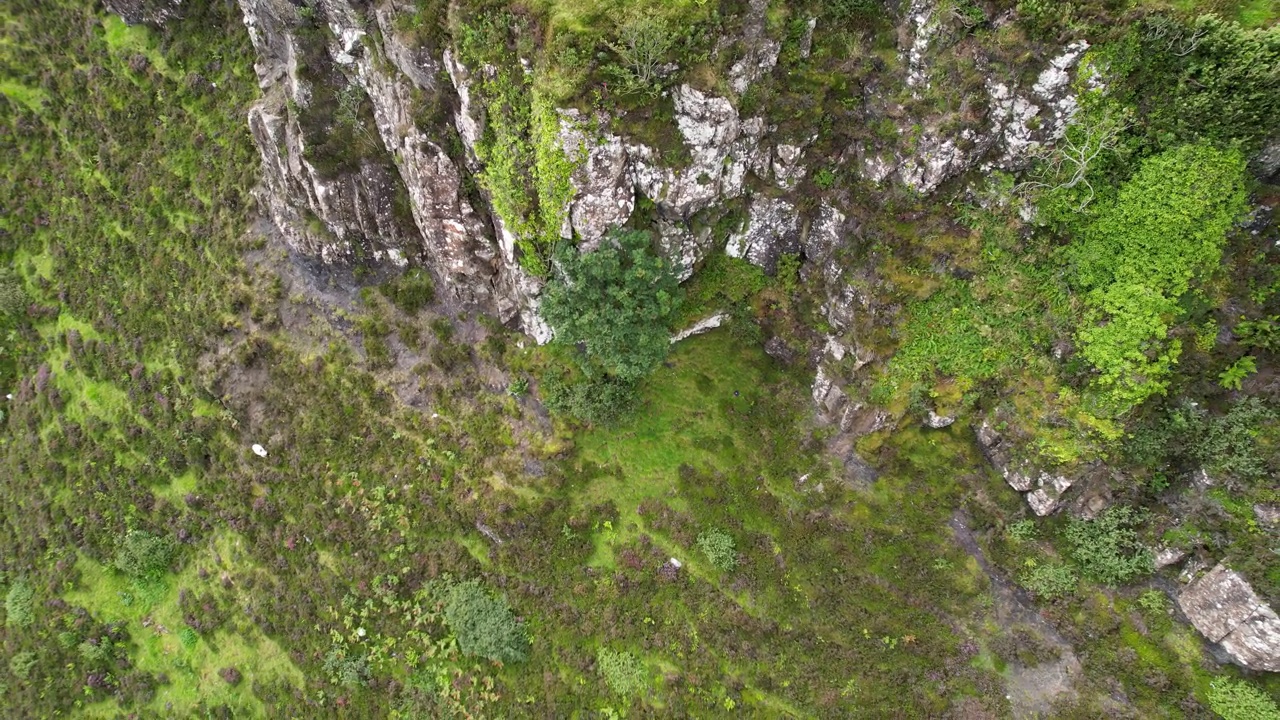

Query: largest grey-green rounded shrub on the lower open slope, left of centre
444,579,529,662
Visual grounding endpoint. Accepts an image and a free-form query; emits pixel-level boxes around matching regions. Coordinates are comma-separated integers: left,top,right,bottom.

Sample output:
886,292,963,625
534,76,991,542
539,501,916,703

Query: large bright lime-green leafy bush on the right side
1065,145,1245,415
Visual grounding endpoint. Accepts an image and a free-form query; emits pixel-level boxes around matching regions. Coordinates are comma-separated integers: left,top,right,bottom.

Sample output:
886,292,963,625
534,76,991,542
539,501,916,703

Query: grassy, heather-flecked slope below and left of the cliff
0,3,1274,717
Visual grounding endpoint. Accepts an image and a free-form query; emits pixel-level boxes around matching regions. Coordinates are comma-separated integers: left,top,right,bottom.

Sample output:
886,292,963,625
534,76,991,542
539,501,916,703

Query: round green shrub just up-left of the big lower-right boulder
1064,506,1155,585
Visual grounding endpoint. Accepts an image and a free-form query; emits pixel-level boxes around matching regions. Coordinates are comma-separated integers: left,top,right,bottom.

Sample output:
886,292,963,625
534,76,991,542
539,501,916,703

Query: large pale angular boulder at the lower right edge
1178,564,1280,673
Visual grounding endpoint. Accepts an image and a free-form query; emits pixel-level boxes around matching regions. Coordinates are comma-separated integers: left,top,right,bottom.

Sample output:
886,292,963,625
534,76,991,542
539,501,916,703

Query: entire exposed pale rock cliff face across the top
227,0,1087,340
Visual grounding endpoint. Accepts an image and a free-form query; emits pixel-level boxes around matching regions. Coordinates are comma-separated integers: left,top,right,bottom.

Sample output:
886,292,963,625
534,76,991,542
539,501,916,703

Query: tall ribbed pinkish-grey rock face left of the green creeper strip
241,0,520,313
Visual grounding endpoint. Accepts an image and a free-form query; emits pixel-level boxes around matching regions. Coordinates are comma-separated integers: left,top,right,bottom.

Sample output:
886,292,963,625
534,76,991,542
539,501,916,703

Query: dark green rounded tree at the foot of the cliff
540,231,678,382
